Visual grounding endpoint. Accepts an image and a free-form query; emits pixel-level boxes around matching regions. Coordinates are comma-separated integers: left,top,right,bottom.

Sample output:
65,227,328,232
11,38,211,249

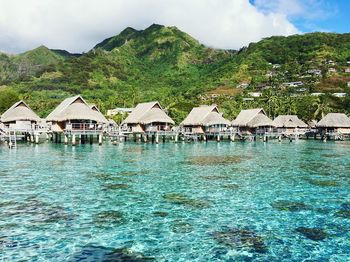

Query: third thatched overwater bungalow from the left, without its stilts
122,101,175,134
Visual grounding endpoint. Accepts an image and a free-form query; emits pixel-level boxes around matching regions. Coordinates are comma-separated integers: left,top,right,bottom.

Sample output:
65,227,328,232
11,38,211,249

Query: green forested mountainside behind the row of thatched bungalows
0,25,350,122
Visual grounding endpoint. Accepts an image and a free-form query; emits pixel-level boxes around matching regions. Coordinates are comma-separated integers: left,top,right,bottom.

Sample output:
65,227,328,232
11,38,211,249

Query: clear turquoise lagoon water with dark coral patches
0,141,350,261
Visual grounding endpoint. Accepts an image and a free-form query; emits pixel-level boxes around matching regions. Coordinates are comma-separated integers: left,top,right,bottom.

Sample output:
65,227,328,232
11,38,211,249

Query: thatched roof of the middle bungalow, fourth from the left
181,105,230,126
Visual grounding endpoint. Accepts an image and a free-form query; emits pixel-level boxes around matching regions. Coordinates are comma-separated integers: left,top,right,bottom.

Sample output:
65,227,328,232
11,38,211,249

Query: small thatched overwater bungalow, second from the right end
273,115,308,136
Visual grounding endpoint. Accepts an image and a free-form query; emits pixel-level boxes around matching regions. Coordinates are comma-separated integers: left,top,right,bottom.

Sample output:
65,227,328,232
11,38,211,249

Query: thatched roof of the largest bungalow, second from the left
46,95,108,123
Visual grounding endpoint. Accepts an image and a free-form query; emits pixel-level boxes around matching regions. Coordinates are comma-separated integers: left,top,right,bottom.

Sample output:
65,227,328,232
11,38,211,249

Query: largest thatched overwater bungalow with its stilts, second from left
46,95,108,144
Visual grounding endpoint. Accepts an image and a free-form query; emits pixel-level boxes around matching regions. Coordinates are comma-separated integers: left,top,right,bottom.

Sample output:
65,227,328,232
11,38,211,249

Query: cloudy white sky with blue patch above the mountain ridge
0,0,350,53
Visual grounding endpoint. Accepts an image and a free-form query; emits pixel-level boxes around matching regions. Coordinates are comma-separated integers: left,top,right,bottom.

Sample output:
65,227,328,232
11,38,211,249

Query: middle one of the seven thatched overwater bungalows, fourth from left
180,105,230,134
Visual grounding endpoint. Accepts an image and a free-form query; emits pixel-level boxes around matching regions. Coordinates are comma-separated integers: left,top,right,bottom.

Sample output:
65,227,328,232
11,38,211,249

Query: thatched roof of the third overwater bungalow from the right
232,108,274,127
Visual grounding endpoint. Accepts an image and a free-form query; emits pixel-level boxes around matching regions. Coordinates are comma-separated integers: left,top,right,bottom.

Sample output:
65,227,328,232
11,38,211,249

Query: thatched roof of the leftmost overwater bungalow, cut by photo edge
1,100,40,123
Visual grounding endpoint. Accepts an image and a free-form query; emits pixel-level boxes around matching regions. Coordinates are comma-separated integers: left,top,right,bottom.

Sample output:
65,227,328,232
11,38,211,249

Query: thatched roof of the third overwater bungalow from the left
123,101,175,124
